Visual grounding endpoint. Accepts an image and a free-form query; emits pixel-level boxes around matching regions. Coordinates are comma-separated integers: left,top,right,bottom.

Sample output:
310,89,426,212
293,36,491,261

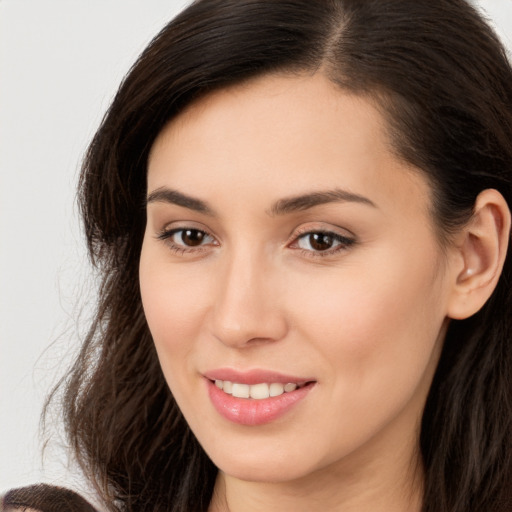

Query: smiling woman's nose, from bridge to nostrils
208,245,288,348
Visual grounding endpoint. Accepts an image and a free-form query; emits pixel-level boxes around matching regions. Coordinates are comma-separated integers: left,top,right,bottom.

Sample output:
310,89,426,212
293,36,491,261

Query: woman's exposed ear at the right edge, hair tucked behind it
447,189,511,320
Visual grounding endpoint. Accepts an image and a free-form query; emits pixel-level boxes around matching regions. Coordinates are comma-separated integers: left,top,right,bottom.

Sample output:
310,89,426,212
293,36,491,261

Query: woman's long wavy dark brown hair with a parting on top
49,0,512,512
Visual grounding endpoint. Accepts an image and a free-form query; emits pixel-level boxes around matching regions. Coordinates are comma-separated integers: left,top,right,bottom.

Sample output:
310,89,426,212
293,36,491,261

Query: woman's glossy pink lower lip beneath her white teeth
206,379,313,426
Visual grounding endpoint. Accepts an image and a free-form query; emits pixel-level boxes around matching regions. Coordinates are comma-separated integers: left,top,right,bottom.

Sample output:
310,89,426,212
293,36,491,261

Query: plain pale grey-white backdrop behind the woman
0,0,512,494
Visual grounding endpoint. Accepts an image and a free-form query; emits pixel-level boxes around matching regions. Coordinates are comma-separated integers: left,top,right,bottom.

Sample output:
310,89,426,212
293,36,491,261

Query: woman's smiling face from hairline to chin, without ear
140,74,456,481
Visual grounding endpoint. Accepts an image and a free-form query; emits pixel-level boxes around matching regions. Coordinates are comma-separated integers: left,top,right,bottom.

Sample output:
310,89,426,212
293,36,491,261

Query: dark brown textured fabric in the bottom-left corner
0,484,97,512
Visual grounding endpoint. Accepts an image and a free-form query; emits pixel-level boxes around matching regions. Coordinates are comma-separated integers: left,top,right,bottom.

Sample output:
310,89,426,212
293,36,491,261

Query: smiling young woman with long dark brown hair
5,0,512,512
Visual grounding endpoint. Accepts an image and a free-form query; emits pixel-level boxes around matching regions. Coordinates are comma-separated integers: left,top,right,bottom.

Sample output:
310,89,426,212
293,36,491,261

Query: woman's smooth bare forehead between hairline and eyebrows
148,74,428,219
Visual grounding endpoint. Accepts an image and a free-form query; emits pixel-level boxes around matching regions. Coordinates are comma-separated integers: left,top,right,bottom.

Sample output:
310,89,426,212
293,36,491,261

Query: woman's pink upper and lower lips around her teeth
203,368,316,426
